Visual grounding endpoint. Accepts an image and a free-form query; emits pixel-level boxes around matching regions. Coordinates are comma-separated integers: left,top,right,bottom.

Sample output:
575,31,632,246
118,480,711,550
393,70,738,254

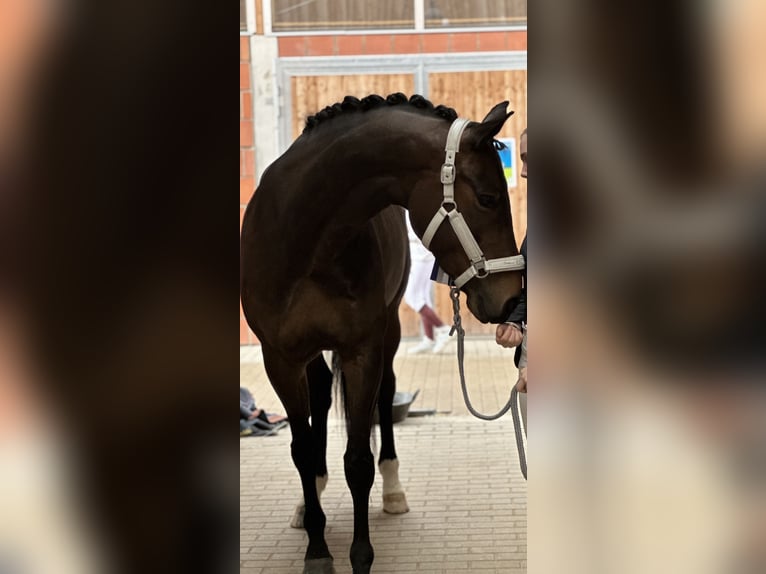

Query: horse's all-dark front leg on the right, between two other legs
341,343,383,574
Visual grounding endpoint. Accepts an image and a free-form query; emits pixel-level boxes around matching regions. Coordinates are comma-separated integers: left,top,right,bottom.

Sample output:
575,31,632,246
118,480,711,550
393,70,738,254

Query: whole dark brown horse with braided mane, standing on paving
240,93,521,574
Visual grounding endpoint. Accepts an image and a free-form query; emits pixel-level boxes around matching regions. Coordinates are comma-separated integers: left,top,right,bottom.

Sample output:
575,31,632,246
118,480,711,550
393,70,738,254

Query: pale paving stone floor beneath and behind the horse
240,338,527,574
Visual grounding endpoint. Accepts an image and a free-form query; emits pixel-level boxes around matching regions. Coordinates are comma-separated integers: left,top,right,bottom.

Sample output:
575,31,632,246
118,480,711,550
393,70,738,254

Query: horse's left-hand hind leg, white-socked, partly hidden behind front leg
290,355,332,528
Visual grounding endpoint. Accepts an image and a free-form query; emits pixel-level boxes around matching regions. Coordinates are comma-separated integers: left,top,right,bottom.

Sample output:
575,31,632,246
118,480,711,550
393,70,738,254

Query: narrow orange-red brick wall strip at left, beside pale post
239,36,257,345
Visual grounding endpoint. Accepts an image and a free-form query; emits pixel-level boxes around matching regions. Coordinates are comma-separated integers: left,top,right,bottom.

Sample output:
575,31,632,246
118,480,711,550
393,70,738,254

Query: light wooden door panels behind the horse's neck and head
291,70,527,337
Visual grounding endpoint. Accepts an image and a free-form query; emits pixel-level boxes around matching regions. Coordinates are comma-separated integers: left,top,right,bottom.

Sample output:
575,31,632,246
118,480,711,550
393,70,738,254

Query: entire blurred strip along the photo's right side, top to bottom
528,0,766,574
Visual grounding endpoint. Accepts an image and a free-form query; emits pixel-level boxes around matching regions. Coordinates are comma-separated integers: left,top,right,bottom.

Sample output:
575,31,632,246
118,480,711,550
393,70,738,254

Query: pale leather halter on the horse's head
421,118,525,289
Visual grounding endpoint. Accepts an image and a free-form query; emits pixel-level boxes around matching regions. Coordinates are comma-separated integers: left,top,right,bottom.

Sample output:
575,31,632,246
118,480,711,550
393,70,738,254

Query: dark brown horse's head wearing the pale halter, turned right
408,102,521,323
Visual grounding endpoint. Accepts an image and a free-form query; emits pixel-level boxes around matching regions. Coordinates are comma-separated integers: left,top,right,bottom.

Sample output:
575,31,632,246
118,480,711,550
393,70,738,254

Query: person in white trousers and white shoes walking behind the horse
404,213,453,354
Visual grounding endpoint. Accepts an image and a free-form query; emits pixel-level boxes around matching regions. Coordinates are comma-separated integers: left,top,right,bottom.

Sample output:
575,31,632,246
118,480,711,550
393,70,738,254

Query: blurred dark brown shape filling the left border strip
15,0,239,573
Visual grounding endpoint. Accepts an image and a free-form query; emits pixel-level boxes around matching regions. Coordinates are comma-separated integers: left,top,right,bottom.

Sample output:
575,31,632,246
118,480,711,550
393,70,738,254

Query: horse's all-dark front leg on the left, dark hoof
263,345,335,574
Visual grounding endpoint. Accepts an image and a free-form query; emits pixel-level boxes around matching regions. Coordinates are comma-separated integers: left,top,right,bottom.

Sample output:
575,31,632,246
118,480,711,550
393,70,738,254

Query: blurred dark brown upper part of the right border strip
528,0,766,378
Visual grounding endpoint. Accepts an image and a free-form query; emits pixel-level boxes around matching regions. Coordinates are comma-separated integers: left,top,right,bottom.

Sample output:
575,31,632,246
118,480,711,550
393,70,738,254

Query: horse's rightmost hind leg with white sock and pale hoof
378,309,410,514
